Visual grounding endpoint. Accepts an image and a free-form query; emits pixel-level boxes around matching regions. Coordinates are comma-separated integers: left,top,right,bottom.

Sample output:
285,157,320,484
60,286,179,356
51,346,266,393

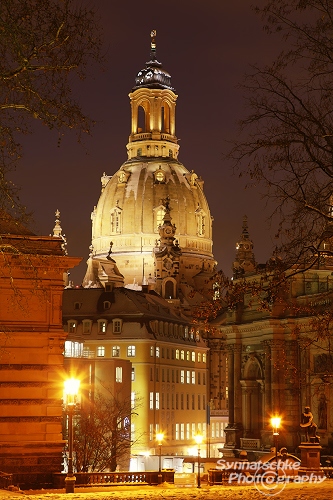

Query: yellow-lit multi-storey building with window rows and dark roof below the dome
63,287,211,468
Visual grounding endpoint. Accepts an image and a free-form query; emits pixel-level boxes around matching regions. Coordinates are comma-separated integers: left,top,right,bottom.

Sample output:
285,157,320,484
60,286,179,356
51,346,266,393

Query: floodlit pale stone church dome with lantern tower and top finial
83,32,216,286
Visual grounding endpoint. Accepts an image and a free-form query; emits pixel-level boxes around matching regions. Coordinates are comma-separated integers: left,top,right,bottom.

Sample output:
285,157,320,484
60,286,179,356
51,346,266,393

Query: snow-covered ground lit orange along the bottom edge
0,479,333,500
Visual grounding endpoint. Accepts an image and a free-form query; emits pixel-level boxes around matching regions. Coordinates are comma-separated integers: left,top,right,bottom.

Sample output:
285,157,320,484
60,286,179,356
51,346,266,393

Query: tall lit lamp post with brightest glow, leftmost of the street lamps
64,378,80,493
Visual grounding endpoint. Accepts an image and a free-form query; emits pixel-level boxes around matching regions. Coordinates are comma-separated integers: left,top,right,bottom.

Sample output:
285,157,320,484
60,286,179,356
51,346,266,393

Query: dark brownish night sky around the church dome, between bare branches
15,0,276,284
